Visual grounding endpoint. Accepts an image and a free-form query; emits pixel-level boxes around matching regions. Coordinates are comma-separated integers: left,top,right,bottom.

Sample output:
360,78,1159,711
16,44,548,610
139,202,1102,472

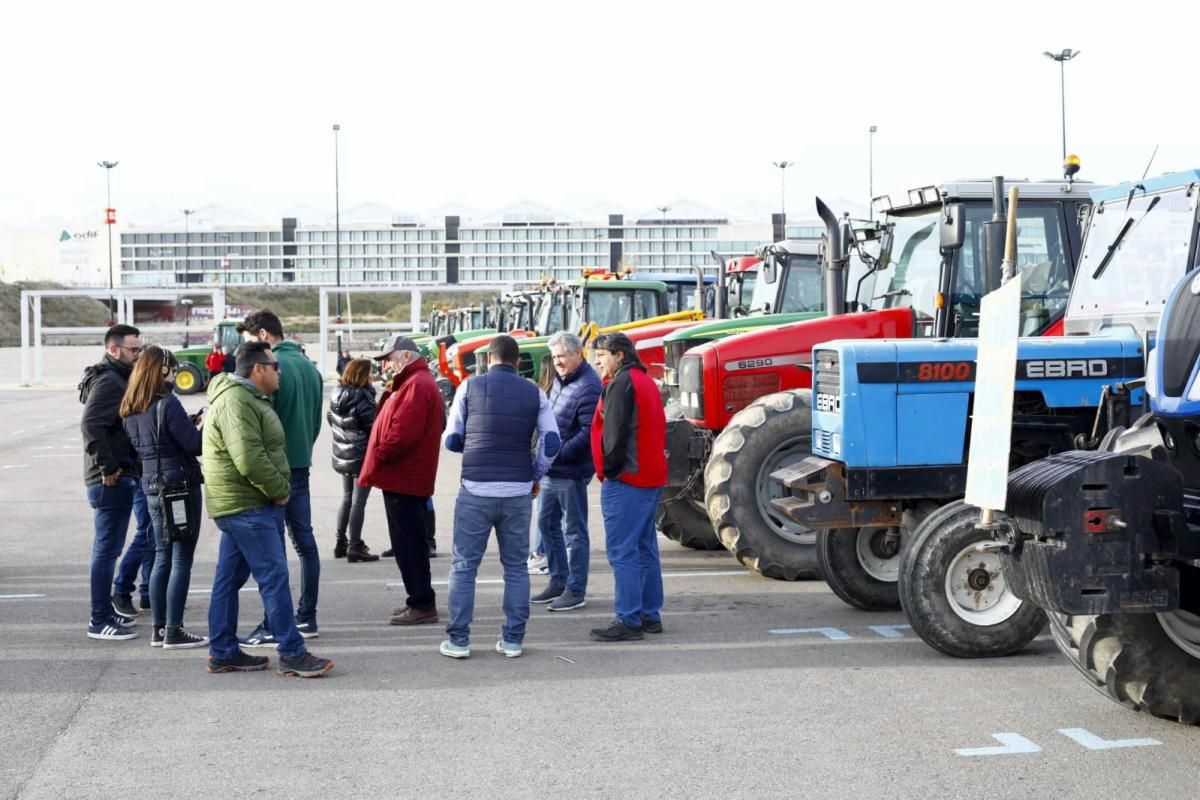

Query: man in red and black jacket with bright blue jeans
592,333,667,642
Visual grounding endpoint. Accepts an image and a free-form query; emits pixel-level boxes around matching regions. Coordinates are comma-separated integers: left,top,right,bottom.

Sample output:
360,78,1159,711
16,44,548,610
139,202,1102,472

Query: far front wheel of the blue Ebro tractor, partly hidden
817,528,900,612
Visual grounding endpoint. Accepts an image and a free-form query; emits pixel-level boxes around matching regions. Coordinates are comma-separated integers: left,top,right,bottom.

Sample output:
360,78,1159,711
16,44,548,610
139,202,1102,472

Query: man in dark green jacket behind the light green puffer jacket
238,308,325,648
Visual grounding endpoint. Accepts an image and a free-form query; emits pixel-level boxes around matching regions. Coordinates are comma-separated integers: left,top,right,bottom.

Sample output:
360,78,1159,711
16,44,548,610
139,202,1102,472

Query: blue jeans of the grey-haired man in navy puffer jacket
538,477,592,595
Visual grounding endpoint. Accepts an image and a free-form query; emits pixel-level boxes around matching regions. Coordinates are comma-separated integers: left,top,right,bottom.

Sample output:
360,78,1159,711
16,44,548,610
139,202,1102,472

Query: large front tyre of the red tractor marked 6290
704,389,821,581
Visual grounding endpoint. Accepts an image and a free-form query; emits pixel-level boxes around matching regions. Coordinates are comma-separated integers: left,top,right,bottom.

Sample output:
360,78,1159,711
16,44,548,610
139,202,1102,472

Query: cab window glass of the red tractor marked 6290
863,200,1072,336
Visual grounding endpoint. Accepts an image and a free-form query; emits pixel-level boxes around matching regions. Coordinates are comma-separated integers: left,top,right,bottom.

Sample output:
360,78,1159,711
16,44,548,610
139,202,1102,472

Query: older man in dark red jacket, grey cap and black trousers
359,335,445,625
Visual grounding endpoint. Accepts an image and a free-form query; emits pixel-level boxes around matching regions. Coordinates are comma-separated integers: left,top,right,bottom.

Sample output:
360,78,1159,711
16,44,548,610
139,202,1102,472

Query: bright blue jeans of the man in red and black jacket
600,480,662,627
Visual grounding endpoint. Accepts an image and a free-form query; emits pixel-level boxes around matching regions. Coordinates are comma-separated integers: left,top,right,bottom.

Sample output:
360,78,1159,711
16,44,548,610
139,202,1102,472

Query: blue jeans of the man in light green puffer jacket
209,506,306,661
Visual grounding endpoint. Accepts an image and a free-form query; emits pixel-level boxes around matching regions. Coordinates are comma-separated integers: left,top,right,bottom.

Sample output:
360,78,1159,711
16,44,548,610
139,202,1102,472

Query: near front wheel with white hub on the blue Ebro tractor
899,500,1046,658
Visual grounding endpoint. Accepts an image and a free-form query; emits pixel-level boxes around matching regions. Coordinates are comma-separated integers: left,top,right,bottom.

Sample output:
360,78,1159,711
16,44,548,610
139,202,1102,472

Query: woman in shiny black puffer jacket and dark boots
325,359,379,563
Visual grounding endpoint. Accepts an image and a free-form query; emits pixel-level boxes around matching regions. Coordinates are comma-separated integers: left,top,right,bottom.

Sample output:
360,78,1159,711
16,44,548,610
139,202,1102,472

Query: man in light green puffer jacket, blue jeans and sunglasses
203,342,334,678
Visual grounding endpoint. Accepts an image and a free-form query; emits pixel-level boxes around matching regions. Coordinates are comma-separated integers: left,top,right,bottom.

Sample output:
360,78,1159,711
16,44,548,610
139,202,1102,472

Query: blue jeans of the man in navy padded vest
446,489,533,644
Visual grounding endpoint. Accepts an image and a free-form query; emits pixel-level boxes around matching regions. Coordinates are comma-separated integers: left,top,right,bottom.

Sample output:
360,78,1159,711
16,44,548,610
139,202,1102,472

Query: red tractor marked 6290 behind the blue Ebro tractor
659,180,1091,566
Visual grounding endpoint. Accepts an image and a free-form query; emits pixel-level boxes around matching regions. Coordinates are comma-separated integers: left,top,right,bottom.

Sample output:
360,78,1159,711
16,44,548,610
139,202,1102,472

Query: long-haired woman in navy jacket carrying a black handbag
120,344,209,650
